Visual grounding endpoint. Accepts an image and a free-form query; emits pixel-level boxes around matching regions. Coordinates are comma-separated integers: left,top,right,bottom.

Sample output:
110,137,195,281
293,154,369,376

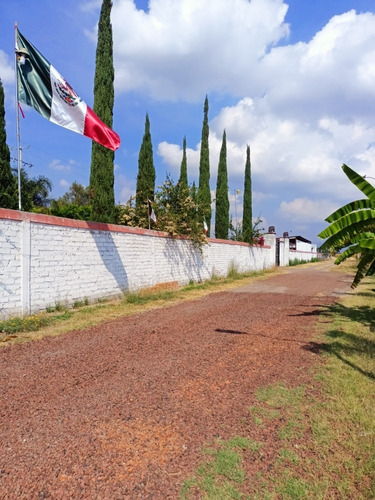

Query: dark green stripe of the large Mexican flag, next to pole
17,30,52,120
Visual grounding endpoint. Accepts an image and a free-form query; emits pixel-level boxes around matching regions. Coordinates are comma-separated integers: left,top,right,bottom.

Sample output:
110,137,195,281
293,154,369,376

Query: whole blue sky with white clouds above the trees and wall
0,0,375,243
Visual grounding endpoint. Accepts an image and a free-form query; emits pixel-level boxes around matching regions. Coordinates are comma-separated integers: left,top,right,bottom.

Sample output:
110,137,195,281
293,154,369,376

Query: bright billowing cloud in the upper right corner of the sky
256,11,375,120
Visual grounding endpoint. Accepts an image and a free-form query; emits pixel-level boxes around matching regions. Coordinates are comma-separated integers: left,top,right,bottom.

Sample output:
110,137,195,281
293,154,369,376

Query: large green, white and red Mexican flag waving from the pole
16,29,120,151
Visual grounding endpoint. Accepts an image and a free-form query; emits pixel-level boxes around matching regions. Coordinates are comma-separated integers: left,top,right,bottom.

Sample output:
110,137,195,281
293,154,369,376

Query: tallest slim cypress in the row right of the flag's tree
198,96,211,236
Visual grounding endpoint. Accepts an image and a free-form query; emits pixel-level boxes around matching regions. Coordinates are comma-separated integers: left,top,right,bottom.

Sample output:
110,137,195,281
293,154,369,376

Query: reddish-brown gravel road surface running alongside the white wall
0,263,351,500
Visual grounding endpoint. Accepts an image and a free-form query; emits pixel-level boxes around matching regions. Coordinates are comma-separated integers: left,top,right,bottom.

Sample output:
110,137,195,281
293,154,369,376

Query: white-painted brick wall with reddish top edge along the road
0,209,275,319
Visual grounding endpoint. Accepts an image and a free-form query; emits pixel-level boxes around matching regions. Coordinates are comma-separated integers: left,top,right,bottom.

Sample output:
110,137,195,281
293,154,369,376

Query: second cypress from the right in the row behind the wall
215,130,229,240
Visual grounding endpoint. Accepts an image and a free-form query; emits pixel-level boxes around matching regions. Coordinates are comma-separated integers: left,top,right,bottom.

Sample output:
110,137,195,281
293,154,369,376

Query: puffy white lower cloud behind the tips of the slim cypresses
158,93,375,200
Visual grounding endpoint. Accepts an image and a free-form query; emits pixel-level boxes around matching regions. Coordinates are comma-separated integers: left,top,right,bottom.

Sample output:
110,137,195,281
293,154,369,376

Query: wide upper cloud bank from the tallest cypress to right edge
112,0,375,117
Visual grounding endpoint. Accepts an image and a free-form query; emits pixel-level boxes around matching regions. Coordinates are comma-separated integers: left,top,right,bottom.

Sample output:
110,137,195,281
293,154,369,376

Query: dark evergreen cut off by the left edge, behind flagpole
0,80,18,209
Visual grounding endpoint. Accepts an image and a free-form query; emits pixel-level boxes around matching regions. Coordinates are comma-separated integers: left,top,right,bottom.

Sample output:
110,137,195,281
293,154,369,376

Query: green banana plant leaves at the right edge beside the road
318,164,375,288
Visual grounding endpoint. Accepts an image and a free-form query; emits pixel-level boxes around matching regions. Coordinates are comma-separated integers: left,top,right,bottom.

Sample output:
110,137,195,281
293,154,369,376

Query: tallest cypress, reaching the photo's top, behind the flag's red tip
90,0,115,222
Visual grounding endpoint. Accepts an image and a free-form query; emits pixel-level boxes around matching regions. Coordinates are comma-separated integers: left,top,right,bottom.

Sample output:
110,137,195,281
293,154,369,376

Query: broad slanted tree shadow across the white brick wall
90,231,129,292
